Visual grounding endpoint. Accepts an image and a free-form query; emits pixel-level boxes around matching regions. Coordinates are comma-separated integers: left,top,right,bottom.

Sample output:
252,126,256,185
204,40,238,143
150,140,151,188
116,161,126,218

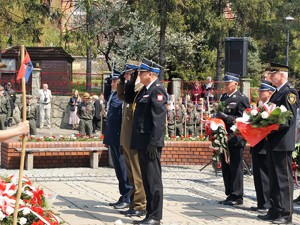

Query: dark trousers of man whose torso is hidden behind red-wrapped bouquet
252,153,271,208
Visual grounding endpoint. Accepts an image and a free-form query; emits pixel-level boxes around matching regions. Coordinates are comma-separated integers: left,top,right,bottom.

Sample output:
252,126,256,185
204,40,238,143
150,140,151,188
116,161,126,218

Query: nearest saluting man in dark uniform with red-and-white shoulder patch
124,59,167,225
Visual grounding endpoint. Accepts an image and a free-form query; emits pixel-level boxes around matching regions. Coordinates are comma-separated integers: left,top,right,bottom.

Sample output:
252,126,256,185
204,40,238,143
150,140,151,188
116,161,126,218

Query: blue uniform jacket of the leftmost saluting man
103,91,123,146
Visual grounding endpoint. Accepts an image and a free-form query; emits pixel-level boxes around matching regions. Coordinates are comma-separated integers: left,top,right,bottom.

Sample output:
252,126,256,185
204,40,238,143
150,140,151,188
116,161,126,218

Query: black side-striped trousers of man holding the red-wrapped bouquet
267,150,294,217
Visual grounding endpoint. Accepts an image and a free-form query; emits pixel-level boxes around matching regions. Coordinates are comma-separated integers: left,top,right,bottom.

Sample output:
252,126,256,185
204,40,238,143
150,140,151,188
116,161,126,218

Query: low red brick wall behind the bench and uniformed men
1,140,251,169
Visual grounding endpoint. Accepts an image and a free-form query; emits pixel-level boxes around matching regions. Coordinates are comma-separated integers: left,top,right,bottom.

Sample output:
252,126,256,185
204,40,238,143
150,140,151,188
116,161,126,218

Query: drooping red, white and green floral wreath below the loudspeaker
205,118,230,163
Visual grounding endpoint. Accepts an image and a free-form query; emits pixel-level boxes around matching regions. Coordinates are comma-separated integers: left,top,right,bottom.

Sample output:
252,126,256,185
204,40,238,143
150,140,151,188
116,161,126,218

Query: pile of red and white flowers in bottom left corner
0,176,60,225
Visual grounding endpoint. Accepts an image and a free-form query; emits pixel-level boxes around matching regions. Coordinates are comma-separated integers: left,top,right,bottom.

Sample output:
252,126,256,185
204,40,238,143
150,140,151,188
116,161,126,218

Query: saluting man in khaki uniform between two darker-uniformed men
117,61,146,216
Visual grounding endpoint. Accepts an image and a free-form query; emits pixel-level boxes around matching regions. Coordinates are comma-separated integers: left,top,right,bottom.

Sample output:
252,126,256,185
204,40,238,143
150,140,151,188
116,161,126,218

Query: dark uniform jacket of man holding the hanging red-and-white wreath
220,91,250,147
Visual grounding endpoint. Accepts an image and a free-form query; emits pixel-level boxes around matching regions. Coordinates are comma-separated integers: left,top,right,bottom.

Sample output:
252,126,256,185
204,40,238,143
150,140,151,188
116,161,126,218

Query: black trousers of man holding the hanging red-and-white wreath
221,147,244,199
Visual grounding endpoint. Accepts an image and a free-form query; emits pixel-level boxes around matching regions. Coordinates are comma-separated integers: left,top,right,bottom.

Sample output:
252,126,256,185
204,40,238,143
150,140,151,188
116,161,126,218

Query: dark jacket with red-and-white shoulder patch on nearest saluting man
131,79,167,150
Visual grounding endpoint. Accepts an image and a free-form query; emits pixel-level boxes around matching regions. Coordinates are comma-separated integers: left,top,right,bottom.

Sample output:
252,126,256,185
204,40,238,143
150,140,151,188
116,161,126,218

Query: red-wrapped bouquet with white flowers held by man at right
231,103,293,147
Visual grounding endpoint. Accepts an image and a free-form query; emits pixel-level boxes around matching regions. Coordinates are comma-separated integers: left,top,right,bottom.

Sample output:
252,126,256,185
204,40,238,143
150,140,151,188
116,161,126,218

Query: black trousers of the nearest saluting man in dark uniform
139,148,163,220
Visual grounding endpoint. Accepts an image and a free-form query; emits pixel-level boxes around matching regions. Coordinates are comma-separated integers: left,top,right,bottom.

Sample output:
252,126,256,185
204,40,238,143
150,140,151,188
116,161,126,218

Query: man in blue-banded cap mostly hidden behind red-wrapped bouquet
250,80,276,212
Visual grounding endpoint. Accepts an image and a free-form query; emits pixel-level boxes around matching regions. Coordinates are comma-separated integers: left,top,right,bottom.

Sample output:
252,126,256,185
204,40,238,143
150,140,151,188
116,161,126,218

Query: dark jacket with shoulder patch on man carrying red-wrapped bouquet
267,82,299,151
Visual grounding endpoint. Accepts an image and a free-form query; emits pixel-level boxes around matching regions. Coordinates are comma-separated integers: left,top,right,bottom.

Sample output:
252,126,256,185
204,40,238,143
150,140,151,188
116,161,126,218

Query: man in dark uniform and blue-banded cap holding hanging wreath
216,72,250,205
